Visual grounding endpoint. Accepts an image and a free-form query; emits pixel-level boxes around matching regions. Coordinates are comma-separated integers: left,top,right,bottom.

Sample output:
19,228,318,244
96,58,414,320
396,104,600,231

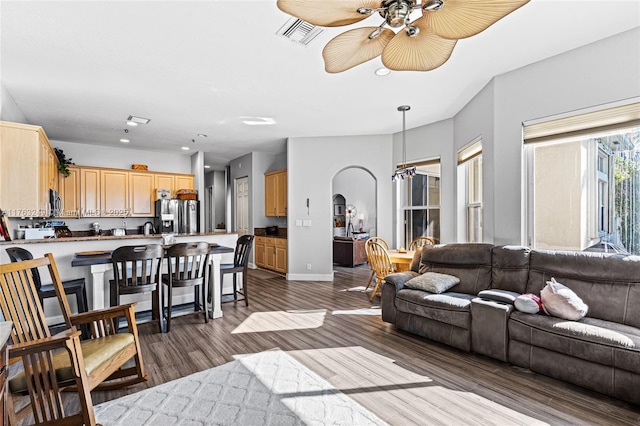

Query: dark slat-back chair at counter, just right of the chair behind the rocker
109,244,164,332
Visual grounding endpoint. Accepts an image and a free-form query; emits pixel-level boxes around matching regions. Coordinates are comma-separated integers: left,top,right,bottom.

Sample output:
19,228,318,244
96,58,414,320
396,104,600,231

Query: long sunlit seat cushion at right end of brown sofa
509,312,640,371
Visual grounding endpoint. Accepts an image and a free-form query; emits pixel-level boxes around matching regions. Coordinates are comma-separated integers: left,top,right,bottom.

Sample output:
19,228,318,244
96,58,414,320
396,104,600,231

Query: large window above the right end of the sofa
525,104,640,254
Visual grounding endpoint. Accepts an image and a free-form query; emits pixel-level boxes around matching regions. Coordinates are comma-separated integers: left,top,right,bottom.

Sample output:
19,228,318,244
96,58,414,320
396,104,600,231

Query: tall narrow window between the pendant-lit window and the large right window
458,141,483,243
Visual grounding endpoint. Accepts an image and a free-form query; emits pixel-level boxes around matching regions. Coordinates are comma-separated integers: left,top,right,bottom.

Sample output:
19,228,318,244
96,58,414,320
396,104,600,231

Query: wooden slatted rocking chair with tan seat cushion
0,253,148,425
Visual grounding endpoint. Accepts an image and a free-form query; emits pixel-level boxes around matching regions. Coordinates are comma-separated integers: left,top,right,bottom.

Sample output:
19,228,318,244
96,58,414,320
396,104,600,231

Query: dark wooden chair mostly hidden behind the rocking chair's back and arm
5,247,88,338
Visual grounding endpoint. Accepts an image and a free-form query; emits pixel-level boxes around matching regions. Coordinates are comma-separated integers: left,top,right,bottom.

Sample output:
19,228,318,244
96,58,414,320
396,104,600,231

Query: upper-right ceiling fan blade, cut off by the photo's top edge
423,0,529,39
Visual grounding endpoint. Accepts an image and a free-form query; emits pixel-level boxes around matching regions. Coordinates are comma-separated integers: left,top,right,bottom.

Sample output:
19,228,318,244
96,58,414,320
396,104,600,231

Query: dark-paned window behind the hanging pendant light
396,159,440,247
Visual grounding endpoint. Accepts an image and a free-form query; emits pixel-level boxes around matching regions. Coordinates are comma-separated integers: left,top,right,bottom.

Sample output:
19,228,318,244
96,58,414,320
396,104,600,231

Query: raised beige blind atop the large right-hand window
524,103,640,144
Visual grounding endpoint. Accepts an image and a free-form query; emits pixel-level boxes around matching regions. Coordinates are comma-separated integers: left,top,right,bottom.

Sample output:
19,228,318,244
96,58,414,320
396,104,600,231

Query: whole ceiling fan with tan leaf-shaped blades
278,0,529,73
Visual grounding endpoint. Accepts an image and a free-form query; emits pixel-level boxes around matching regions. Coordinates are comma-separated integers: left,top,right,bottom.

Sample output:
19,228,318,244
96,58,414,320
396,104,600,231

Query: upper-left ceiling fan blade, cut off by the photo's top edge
278,0,381,27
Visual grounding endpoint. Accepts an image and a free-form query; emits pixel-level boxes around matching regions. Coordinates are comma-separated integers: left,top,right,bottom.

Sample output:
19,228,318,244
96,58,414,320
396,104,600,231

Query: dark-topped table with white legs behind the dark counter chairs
71,244,235,319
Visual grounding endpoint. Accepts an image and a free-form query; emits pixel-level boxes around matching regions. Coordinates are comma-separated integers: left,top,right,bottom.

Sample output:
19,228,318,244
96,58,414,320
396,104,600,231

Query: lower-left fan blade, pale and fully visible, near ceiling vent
322,27,395,73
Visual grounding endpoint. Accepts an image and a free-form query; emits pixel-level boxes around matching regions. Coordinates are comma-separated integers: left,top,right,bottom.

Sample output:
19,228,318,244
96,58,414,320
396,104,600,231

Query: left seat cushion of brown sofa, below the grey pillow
396,288,475,329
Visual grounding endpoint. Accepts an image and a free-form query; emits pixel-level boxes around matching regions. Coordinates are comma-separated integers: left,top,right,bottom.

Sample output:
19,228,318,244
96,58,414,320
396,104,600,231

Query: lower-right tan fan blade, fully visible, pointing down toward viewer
382,19,458,71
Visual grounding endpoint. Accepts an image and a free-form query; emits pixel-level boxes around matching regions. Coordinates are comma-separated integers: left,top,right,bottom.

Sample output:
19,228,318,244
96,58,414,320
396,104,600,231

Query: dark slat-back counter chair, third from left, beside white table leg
162,241,209,332
